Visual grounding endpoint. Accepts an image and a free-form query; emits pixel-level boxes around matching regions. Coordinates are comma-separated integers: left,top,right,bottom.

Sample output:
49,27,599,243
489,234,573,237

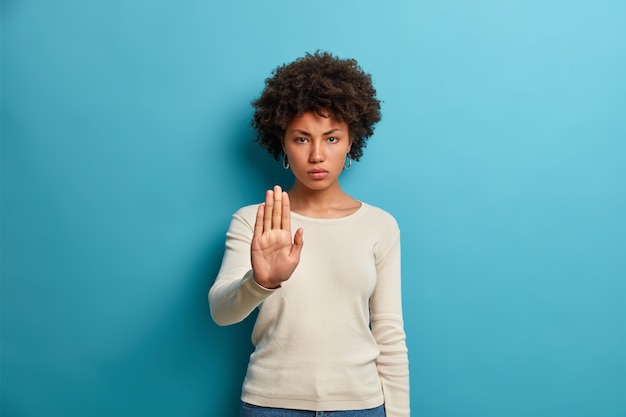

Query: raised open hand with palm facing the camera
250,185,304,288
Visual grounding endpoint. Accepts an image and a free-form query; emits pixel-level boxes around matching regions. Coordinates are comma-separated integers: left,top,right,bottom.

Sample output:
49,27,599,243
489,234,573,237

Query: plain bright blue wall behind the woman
1,0,626,417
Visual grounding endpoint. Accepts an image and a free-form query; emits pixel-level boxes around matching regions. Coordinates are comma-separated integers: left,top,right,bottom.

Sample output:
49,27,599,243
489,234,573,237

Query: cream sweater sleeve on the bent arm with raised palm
209,206,274,326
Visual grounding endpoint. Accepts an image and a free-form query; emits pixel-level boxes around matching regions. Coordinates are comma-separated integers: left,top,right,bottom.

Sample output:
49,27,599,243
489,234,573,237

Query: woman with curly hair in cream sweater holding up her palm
209,52,409,417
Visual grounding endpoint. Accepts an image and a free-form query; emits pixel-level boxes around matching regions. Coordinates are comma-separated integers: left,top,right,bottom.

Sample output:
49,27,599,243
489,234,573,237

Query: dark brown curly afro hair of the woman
250,51,381,161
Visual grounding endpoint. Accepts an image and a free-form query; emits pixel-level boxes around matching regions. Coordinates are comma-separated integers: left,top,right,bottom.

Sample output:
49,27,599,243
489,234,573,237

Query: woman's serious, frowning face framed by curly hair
283,111,352,191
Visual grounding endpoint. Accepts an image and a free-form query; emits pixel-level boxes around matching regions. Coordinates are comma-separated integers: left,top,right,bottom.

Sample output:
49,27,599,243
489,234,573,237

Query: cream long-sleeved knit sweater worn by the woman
209,204,410,417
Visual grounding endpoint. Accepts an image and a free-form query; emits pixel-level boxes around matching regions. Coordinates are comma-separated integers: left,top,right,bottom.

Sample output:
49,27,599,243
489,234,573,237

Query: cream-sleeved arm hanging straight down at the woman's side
370,229,410,417
